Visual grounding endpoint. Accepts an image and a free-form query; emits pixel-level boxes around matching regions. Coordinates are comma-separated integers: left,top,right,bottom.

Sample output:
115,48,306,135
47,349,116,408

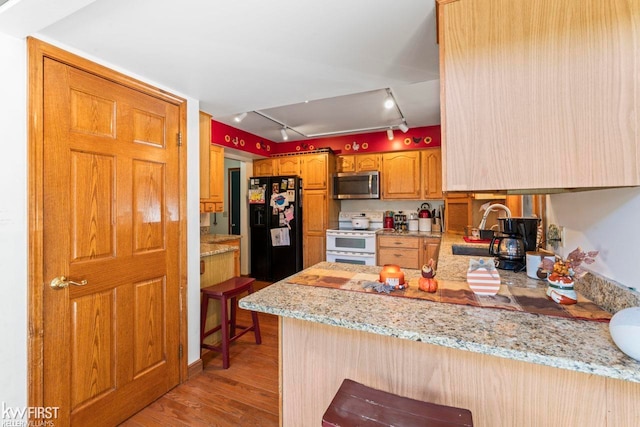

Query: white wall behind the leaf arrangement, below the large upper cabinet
547,188,640,289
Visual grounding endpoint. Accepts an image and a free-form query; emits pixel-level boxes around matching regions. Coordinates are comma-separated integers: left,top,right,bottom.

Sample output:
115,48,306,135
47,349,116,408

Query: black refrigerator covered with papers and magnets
249,176,302,281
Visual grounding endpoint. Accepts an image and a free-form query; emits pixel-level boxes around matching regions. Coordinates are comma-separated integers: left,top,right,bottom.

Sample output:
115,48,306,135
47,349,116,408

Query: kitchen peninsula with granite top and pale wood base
240,235,640,427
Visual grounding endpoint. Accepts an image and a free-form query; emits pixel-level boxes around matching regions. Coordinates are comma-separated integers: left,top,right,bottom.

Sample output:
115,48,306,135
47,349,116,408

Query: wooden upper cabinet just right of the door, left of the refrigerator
199,111,224,213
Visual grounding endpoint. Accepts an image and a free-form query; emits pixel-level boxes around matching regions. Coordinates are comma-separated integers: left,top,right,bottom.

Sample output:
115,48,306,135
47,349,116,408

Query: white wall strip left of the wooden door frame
0,30,27,407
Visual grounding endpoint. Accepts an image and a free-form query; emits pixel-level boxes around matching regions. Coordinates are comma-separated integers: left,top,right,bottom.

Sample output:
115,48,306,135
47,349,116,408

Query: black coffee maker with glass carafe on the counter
489,217,540,272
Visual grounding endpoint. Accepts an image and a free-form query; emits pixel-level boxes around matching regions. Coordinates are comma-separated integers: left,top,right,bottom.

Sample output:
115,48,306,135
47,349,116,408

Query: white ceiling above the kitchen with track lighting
0,0,440,141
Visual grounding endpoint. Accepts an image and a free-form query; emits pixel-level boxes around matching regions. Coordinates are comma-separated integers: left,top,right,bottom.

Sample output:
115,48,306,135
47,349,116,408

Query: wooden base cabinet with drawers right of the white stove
377,235,440,269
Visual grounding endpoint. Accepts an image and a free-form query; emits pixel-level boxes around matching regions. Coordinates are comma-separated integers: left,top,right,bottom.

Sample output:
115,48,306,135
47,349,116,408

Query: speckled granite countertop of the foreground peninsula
240,234,640,383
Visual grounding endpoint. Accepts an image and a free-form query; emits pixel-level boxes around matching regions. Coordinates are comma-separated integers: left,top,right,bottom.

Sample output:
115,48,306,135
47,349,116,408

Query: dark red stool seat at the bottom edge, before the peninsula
322,379,473,427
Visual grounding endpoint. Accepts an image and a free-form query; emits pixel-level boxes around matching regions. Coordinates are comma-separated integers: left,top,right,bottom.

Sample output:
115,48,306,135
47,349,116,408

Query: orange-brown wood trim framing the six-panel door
27,37,189,406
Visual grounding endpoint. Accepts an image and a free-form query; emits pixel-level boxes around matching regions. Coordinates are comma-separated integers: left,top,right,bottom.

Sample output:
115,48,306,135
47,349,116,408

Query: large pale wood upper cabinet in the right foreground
438,0,640,191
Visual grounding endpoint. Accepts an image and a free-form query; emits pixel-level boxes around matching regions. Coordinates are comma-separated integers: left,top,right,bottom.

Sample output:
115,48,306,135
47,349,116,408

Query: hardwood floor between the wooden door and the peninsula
121,283,279,427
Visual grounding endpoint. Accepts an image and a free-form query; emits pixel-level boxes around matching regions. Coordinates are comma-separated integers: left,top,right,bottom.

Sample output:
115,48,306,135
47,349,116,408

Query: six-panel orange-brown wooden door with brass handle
42,58,181,426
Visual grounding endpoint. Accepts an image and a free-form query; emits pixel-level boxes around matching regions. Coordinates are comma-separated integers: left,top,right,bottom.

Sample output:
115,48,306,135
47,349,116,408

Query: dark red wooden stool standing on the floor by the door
200,277,262,369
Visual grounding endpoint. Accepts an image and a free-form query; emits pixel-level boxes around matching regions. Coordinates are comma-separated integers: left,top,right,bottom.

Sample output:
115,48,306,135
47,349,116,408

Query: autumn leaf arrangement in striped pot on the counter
541,248,598,304
